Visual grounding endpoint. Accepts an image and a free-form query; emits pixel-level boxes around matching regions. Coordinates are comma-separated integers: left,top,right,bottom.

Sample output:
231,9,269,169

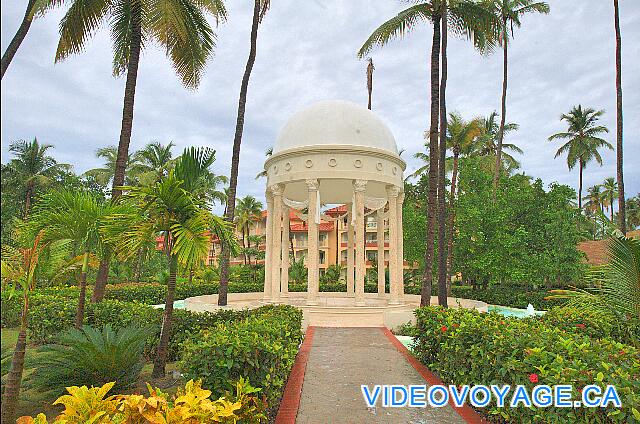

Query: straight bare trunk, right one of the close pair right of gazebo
438,1,447,308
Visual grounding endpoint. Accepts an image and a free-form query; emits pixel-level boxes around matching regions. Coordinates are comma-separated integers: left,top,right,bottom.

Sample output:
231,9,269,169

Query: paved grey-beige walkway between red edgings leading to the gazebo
296,327,465,424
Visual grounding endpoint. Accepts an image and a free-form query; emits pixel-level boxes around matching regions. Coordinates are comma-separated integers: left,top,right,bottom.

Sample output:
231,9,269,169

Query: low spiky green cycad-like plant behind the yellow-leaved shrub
31,324,150,393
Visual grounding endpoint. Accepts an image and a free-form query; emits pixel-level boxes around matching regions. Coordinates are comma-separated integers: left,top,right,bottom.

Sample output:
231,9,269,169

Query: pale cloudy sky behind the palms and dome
1,0,640,212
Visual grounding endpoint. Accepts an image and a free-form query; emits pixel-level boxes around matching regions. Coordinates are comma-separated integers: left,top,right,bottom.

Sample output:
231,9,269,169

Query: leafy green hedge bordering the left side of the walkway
179,305,302,408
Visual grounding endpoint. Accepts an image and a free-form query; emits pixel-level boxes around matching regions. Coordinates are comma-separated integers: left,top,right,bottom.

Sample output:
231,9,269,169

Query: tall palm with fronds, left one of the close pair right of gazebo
358,0,494,305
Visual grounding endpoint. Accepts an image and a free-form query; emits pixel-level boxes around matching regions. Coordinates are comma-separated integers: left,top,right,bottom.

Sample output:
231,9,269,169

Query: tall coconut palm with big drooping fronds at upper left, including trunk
56,0,227,301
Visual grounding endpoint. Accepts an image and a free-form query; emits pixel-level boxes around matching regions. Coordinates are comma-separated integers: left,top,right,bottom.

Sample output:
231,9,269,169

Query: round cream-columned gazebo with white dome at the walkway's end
263,101,406,306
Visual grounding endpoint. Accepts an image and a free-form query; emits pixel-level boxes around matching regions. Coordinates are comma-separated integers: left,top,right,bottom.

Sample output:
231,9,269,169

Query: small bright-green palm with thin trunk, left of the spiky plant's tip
33,190,124,328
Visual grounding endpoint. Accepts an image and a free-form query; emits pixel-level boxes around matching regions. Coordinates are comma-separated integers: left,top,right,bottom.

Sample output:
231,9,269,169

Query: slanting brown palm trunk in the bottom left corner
0,290,29,423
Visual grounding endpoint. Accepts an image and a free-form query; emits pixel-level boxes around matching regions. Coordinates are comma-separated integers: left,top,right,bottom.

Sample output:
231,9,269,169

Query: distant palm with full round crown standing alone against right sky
549,105,613,212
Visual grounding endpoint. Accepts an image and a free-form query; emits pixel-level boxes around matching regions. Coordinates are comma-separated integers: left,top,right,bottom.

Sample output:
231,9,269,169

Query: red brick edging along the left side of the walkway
276,326,315,424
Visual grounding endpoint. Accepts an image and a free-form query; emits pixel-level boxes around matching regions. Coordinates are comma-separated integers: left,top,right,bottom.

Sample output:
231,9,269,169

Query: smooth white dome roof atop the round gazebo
273,100,398,155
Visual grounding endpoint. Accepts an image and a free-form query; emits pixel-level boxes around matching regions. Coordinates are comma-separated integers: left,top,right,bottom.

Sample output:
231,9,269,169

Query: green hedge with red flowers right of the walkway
414,307,640,423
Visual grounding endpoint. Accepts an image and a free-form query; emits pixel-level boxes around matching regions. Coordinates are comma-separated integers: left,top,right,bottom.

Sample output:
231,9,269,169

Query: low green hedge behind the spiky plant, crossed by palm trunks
23,296,248,361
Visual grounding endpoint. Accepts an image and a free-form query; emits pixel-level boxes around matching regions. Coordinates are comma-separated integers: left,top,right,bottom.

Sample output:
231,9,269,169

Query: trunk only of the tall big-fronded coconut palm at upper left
91,7,142,302
